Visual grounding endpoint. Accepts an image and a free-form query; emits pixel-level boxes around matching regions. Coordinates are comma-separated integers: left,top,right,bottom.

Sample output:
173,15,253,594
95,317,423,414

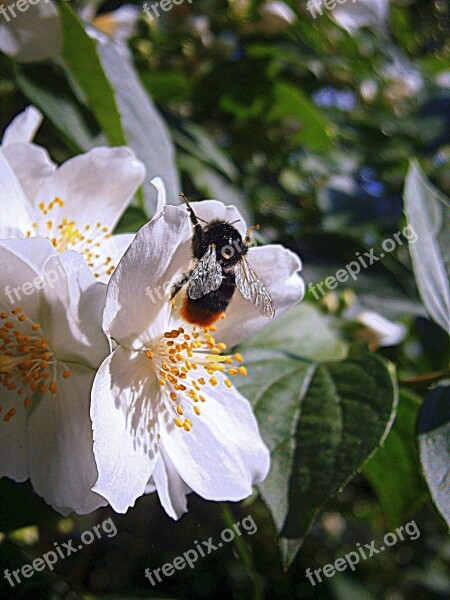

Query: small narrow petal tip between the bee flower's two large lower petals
153,444,192,520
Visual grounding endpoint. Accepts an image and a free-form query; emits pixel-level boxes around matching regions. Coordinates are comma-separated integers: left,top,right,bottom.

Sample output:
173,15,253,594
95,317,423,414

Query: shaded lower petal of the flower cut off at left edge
27,365,107,514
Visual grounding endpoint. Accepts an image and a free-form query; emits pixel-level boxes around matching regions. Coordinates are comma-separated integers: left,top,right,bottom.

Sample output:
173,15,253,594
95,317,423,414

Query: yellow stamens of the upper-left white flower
25,198,115,278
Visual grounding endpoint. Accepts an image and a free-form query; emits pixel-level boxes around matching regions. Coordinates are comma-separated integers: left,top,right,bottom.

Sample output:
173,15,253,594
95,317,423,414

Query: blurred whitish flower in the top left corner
0,0,62,62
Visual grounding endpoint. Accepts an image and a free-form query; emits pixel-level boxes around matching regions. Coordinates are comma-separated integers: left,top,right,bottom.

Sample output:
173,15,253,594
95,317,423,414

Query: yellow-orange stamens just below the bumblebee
145,325,247,431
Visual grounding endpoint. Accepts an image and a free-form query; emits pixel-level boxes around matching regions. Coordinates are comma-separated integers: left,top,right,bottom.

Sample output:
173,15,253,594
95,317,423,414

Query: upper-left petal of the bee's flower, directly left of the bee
103,206,192,348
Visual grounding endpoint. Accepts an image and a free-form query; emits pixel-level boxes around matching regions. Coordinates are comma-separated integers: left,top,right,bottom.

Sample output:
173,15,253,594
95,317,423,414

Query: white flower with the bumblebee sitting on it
91,180,304,518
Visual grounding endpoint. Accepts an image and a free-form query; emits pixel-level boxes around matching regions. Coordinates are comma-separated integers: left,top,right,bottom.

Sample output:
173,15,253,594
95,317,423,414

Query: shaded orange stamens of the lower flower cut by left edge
0,306,70,423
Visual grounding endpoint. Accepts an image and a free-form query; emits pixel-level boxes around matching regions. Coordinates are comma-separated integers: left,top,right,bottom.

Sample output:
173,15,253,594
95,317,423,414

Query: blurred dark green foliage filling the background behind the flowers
0,0,450,600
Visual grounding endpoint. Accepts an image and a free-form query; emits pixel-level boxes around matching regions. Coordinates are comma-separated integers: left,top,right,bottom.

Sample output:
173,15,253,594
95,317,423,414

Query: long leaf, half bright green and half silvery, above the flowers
59,3,180,215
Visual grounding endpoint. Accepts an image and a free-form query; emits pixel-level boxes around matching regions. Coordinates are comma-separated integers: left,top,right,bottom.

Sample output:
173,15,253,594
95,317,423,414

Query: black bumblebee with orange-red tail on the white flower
171,194,275,327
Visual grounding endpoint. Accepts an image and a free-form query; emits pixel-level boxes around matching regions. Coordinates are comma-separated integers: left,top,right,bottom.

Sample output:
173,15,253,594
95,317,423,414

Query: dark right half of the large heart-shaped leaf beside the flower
282,354,397,538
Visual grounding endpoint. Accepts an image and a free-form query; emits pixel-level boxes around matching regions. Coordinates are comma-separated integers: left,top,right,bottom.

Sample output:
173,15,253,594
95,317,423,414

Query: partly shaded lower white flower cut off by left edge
0,238,109,514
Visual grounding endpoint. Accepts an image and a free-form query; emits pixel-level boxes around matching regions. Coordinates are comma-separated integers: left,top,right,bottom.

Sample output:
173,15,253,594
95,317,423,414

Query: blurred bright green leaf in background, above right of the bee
268,82,332,150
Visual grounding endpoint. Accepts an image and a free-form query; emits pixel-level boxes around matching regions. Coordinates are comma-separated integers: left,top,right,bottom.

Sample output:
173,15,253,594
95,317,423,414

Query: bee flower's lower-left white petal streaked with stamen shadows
91,346,159,513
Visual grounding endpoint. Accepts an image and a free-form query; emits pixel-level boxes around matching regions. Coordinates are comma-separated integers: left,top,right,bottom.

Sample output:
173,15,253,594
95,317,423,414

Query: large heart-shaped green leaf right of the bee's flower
238,304,397,564
